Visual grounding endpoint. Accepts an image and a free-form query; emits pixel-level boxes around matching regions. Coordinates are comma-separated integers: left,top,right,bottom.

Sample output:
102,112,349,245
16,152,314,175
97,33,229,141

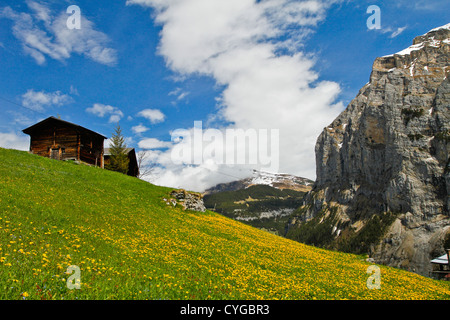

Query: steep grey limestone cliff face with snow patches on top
290,24,450,275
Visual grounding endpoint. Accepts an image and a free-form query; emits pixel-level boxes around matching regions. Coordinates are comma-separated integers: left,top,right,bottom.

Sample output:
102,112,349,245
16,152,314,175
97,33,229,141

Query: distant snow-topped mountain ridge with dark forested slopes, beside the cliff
203,170,314,236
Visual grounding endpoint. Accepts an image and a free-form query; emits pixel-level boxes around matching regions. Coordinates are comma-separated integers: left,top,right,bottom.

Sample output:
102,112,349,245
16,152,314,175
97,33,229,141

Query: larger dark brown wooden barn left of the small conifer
23,117,107,168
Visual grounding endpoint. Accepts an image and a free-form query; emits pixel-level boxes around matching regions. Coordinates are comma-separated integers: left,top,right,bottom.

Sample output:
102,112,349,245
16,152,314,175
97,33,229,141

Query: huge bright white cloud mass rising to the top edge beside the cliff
127,0,344,190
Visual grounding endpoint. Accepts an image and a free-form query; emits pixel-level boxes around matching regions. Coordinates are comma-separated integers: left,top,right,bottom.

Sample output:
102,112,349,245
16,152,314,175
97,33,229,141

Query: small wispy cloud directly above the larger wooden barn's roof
22,89,73,111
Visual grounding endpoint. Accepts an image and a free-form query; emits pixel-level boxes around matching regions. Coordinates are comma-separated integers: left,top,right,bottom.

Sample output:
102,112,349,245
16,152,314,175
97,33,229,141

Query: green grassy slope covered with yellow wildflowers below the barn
0,149,450,299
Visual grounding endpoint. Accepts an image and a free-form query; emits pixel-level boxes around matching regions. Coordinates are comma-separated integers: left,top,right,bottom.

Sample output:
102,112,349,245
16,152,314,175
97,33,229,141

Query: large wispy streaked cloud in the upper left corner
0,1,117,65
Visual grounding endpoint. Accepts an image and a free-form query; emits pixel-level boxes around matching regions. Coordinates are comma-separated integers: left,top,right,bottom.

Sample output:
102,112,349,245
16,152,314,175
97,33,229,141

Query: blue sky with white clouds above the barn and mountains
0,0,450,191
